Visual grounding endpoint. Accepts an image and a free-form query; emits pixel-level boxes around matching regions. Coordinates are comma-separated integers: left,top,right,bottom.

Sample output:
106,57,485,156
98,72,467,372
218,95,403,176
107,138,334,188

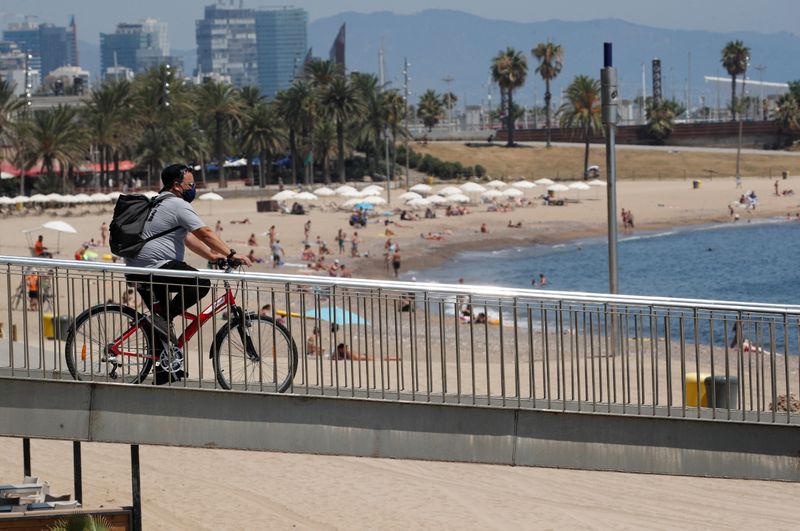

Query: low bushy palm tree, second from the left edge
31,105,86,191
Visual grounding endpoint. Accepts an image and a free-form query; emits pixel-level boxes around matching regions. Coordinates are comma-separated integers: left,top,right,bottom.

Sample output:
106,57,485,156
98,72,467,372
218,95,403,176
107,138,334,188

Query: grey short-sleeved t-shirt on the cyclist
125,192,206,268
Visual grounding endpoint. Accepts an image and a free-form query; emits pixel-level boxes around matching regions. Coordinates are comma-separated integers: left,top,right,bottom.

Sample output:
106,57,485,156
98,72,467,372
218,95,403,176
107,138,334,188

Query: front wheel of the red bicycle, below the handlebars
211,315,297,393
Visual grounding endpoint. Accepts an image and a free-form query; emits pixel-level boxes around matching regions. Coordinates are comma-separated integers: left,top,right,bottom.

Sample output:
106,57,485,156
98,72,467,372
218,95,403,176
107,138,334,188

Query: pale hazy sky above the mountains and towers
0,0,800,49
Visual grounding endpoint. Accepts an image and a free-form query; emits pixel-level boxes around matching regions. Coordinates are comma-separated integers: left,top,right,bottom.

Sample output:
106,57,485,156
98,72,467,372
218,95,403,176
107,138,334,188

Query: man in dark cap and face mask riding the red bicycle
125,164,252,342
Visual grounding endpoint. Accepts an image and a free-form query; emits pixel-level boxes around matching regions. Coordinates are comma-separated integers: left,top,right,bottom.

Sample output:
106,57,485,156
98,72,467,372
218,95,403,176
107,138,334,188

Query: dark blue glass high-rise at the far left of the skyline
3,17,78,75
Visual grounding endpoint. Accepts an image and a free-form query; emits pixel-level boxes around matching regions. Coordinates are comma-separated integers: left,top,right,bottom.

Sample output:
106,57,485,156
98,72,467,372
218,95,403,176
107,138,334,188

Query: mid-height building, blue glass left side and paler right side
100,18,174,78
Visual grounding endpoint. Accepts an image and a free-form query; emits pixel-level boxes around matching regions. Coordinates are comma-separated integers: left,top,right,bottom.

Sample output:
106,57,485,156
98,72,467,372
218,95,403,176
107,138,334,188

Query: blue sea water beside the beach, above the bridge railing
410,219,800,304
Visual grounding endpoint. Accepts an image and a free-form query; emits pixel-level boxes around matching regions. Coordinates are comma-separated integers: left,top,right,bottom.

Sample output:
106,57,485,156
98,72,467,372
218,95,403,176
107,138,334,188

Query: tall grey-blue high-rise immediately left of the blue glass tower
195,2,258,87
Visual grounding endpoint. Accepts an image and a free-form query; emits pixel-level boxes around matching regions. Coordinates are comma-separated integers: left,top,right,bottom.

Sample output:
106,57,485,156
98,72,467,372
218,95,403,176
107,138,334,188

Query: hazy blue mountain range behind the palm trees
79,9,800,106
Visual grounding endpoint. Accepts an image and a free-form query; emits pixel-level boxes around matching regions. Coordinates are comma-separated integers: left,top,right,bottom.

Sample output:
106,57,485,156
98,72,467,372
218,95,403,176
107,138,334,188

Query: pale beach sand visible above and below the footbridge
0,178,800,529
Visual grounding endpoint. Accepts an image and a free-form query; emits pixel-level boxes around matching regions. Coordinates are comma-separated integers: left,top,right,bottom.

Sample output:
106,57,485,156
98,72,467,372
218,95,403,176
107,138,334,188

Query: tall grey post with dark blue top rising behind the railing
600,42,619,293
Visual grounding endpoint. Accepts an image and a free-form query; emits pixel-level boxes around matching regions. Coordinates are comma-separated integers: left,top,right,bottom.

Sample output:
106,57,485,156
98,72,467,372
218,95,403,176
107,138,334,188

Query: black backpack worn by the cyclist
109,194,180,258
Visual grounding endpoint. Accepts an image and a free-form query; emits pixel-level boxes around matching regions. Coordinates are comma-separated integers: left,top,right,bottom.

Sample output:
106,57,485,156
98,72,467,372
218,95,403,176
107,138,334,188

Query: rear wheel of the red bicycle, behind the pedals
64,304,153,383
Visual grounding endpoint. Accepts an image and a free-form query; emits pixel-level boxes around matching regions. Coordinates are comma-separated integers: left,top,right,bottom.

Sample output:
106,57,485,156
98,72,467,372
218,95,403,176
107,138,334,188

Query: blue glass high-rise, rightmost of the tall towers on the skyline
256,7,308,98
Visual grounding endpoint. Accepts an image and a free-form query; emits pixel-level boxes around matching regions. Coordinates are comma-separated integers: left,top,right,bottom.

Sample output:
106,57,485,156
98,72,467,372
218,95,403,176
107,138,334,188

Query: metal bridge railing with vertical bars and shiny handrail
0,257,800,424
